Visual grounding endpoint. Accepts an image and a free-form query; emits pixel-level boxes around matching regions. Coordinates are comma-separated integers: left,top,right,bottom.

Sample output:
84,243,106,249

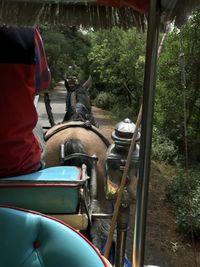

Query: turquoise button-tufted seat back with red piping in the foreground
0,206,107,267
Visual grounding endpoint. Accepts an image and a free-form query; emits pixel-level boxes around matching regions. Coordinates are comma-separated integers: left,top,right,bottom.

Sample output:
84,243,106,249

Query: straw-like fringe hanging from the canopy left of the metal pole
0,0,145,29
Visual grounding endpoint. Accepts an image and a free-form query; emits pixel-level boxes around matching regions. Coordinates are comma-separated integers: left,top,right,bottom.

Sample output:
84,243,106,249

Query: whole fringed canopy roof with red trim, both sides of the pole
0,0,200,29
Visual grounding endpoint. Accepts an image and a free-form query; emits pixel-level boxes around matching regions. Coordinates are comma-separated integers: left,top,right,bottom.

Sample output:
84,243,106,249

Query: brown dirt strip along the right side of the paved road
93,107,200,267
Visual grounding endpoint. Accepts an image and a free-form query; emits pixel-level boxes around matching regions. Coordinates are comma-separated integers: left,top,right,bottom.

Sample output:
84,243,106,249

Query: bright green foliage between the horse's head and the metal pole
89,27,145,118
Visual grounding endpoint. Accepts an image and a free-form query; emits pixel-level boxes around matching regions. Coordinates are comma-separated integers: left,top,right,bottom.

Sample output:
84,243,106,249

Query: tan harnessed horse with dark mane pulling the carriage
45,75,112,247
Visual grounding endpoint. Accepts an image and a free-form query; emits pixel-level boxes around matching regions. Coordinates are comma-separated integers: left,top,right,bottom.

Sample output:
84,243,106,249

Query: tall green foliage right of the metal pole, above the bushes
155,13,200,161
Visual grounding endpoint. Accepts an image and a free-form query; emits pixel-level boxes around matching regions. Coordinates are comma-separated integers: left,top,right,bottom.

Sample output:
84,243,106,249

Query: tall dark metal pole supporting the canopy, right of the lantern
133,0,160,267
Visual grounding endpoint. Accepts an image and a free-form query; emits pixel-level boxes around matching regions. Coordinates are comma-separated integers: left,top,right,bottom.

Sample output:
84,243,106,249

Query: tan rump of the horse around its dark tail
46,121,109,202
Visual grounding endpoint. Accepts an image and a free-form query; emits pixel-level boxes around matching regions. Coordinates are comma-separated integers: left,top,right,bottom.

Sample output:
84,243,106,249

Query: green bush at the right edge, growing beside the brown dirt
166,169,200,238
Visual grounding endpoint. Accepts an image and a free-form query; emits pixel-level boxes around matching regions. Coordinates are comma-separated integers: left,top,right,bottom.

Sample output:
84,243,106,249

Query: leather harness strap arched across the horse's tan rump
45,121,110,147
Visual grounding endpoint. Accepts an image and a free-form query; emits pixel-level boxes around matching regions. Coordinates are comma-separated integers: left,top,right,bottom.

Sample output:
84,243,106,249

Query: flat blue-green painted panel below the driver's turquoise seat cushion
0,186,79,215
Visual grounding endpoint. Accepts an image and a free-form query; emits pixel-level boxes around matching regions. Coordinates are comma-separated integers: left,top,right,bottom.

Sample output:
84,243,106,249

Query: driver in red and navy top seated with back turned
0,26,51,177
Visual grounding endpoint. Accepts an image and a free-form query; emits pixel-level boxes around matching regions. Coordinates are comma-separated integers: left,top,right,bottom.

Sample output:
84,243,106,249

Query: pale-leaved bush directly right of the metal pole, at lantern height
152,127,178,163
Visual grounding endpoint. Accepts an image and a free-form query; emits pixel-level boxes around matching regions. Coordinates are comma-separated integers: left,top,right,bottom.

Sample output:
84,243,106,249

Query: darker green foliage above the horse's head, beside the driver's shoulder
41,25,91,87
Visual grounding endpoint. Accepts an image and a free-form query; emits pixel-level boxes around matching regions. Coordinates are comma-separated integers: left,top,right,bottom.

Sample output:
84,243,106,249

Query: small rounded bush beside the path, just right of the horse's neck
94,92,115,110
